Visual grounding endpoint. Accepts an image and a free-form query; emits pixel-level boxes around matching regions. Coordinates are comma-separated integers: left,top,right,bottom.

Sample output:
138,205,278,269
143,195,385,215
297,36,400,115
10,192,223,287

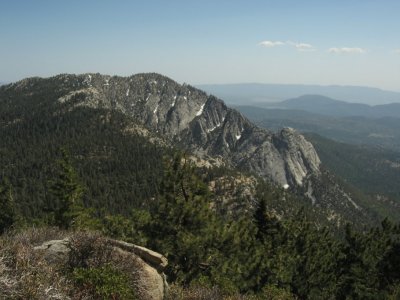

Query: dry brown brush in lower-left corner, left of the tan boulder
0,228,140,300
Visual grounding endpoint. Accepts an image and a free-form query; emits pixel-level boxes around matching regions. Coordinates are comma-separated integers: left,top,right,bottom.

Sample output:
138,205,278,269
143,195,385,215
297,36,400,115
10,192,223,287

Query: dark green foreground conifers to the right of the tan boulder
83,154,400,299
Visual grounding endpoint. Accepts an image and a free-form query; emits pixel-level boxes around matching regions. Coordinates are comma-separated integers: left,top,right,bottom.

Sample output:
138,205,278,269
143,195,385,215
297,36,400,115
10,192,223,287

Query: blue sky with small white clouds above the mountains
0,0,400,91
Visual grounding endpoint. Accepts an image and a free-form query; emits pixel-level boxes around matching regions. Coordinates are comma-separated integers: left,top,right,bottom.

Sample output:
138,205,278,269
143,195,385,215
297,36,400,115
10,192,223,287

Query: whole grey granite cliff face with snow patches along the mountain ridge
6,73,320,188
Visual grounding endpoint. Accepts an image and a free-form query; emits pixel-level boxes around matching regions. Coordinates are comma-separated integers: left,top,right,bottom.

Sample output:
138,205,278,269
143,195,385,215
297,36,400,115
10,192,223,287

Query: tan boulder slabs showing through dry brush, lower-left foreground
34,238,168,300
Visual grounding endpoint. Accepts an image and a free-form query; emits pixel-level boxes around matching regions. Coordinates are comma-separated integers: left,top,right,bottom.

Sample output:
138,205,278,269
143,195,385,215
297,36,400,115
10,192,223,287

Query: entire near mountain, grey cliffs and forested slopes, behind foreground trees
0,73,385,228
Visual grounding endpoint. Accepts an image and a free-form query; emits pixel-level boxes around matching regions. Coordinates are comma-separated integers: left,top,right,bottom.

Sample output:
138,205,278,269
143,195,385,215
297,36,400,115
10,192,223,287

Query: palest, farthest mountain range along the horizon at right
197,83,400,106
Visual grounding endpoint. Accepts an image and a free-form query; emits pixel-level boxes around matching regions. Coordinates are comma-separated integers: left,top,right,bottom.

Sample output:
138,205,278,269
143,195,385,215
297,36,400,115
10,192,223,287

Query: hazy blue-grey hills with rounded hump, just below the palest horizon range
236,106,400,151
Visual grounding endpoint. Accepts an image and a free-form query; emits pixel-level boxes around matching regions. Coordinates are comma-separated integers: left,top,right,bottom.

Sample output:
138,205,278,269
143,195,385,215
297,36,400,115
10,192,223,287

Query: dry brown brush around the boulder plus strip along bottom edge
0,228,293,300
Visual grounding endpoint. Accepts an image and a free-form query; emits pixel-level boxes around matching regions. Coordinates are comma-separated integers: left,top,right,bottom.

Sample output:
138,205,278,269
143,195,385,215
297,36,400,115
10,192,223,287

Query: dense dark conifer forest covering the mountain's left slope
0,96,164,219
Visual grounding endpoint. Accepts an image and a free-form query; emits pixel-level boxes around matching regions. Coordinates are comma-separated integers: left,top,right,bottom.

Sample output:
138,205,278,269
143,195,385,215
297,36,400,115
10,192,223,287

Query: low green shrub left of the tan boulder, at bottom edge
72,265,136,299
